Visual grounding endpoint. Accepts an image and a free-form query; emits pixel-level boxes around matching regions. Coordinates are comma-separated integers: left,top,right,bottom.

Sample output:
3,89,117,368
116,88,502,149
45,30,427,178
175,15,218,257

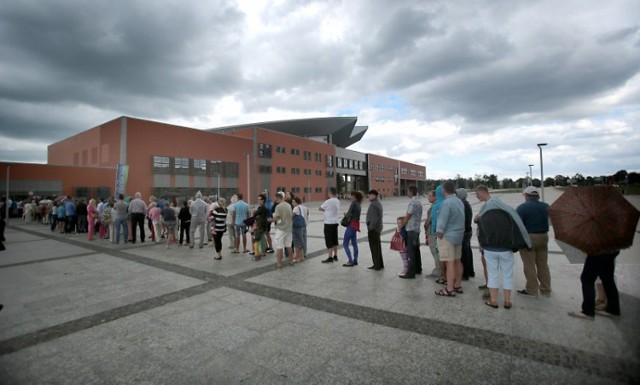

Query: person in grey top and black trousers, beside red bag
398,186,422,279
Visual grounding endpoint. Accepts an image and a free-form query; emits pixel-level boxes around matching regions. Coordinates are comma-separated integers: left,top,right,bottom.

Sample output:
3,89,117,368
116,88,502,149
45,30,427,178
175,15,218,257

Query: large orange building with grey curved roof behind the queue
0,116,426,203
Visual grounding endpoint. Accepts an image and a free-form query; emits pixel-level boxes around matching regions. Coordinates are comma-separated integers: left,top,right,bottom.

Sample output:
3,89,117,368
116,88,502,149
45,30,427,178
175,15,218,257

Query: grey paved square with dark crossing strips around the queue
0,189,640,384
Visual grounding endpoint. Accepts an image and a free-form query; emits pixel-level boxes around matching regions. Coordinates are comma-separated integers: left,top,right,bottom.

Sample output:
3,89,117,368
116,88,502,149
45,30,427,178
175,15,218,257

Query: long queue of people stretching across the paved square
0,182,620,319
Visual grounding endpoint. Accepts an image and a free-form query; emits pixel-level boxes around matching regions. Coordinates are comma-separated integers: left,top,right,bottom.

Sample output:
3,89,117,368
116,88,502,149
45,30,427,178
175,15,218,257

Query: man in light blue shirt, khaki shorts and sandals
435,182,464,297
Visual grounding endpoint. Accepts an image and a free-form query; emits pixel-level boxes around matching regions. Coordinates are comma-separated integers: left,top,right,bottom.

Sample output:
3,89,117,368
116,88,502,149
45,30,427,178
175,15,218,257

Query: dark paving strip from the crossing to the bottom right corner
226,281,638,383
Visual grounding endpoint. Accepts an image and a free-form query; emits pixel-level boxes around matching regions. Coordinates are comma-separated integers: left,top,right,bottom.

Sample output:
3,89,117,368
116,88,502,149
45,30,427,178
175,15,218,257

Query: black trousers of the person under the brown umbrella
580,252,620,316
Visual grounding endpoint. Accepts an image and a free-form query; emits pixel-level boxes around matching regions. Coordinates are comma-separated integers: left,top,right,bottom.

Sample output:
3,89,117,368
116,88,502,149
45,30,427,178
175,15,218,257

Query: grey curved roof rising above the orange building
207,116,368,148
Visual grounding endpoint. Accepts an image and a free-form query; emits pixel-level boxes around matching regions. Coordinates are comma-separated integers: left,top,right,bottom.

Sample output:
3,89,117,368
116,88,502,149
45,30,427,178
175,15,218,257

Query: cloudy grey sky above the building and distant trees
0,0,640,179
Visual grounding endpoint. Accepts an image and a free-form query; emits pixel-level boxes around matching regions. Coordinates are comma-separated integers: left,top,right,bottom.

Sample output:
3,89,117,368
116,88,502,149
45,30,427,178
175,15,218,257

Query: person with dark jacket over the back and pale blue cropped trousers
476,185,531,309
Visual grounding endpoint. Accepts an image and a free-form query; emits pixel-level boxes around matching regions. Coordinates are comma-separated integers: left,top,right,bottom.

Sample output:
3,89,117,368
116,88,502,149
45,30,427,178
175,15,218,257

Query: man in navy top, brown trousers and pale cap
516,186,551,297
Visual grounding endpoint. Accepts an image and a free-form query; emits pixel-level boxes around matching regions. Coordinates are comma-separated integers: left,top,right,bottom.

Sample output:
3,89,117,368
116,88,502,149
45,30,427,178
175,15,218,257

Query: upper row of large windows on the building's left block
153,156,240,177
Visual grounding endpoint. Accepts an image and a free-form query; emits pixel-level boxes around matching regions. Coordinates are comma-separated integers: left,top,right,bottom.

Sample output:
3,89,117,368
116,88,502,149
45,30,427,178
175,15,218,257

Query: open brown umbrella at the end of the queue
549,186,640,255
